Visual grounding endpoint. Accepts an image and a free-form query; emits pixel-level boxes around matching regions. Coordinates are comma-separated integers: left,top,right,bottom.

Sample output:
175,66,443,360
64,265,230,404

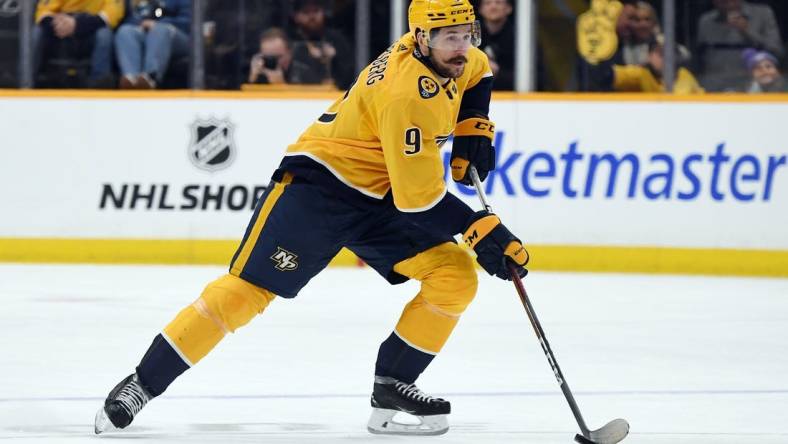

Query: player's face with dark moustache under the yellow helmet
430,25,475,79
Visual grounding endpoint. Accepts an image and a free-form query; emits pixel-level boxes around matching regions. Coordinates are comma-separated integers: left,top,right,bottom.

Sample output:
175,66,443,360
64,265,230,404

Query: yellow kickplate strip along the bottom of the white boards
0,238,788,277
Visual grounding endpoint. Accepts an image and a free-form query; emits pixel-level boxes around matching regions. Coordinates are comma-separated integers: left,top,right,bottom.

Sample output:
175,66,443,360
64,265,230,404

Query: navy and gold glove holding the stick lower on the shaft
462,211,529,280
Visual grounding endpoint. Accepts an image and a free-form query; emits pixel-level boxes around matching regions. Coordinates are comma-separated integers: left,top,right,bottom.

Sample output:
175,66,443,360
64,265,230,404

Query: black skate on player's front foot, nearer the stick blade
367,376,451,435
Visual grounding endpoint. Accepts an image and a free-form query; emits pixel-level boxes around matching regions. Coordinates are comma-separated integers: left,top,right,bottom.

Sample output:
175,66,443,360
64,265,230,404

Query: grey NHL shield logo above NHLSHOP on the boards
189,118,235,171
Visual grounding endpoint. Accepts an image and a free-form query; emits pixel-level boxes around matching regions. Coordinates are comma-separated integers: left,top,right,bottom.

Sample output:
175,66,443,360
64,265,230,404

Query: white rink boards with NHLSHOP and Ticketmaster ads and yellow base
0,91,788,276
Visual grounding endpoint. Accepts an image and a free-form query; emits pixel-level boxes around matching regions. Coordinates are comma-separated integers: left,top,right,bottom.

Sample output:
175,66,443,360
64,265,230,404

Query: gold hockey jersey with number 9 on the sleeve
286,34,492,212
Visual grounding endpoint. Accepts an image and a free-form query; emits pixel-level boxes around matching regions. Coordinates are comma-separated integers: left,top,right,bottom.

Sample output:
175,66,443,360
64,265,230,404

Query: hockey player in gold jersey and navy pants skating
95,0,528,434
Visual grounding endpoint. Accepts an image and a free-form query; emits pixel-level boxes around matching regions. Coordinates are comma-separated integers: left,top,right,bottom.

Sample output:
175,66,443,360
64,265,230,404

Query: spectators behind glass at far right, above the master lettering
578,0,788,94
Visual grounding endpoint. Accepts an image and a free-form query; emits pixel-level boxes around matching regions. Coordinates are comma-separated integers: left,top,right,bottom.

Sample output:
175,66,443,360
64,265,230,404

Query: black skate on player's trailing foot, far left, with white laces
95,373,151,435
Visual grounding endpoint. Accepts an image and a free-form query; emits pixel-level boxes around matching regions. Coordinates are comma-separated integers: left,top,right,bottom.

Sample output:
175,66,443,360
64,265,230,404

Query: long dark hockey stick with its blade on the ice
470,166,629,444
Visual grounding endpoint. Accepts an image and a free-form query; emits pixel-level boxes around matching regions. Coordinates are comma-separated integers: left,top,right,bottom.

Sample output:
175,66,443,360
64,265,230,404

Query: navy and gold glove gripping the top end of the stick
451,117,495,185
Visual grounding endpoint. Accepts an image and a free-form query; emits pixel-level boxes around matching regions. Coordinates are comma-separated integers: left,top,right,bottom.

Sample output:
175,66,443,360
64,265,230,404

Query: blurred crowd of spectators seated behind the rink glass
0,0,788,94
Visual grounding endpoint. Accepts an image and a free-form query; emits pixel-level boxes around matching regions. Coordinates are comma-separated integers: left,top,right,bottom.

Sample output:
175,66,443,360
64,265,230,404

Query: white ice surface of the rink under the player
0,265,788,444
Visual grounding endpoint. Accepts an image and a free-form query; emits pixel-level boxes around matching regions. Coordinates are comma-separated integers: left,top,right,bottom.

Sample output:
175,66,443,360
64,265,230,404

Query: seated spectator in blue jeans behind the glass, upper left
115,0,192,89
